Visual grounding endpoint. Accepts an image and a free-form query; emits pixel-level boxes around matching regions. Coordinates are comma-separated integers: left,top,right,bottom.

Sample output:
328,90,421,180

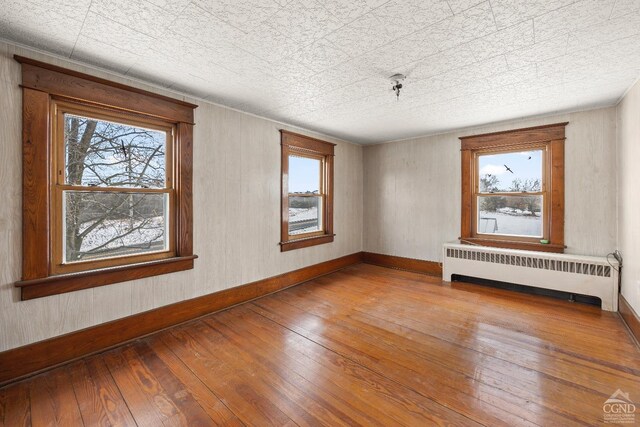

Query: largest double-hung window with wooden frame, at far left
16,57,196,299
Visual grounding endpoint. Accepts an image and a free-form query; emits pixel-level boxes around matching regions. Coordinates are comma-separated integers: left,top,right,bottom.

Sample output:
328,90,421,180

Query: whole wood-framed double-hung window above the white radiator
460,123,567,252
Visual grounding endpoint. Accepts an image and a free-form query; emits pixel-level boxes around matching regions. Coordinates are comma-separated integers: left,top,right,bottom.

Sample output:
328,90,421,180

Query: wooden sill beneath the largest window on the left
15,255,198,301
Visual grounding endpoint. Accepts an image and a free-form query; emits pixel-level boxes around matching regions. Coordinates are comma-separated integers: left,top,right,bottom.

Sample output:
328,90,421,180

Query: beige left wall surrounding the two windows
0,43,363,351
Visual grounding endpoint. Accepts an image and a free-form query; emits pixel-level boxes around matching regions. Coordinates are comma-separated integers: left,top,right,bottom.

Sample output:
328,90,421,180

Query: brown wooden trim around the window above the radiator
460,122,568,253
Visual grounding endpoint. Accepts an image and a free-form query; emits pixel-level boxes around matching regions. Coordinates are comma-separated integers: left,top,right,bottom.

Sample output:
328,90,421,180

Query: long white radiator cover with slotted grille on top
442,243,618,311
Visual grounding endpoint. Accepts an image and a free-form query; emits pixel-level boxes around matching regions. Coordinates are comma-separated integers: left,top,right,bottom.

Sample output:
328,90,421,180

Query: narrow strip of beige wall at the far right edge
617,82,640,313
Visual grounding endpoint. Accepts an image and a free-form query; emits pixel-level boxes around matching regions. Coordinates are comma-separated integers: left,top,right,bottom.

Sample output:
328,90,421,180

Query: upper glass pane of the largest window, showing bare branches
64,114,167,188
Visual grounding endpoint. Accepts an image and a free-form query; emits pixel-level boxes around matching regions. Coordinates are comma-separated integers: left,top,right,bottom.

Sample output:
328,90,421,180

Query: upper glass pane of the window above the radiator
478,150,543,193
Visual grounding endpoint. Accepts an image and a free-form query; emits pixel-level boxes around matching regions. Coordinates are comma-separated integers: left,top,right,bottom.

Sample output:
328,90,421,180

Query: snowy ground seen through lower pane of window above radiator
478,208,542,238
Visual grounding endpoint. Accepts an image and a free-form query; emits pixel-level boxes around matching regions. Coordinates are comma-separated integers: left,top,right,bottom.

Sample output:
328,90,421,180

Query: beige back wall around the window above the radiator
364,107,620,261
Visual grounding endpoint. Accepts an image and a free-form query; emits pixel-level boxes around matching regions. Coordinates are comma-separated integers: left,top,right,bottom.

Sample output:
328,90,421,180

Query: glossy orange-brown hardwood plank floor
0,264,640,426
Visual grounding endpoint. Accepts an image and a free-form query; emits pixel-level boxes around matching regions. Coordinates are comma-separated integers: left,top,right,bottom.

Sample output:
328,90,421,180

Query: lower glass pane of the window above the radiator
477,196,542,238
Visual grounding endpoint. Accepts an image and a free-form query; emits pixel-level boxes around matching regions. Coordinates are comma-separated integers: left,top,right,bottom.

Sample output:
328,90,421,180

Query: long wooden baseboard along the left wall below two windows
0,252,362,386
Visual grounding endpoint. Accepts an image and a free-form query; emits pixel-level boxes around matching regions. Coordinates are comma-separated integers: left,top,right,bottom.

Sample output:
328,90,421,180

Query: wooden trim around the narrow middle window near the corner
280,129,336,252
